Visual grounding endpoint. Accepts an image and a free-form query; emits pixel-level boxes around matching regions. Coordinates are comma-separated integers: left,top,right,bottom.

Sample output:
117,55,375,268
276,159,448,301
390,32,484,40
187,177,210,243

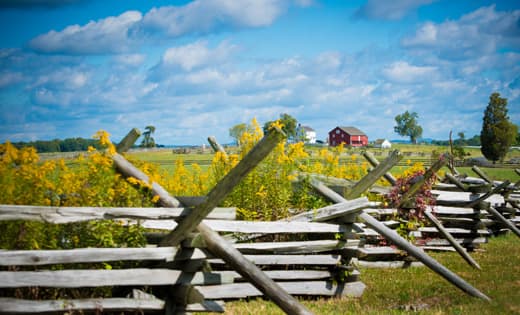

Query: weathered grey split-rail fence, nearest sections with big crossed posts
0,130,512,314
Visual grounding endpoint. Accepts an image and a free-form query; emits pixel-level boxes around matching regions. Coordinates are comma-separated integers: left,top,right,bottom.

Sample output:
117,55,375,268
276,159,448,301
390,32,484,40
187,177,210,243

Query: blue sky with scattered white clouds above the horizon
0,0,520,145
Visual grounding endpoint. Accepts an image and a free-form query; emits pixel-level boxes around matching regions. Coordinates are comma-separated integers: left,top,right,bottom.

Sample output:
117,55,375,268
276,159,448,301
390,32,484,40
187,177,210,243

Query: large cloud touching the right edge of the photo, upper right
401,5,520,59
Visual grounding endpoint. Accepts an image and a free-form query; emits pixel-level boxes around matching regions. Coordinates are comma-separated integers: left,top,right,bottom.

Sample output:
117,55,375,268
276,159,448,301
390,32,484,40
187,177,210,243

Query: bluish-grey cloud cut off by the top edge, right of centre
354,0,436,20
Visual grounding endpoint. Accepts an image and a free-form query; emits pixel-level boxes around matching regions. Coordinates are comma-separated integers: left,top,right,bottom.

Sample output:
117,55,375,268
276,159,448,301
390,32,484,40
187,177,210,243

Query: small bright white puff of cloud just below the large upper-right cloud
383,61,437,83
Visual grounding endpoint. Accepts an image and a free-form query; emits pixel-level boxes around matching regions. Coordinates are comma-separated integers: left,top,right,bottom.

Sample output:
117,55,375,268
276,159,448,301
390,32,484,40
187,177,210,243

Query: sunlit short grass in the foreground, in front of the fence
214,233,520,314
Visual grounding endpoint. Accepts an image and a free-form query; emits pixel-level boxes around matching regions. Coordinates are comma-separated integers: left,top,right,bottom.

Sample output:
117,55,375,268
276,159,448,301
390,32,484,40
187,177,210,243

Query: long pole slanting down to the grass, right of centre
311,182,491,301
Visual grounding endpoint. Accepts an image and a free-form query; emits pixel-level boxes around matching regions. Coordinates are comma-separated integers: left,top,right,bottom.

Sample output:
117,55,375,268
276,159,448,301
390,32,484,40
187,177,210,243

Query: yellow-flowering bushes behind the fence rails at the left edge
0,132,154,298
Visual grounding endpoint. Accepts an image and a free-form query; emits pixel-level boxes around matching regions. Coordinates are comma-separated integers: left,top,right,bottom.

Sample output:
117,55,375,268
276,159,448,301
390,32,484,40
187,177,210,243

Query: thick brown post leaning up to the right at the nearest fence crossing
161,128,285,246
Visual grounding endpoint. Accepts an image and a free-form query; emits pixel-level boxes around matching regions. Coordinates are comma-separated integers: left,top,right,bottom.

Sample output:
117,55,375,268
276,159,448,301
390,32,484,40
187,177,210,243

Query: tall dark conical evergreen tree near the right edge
480,92,518,163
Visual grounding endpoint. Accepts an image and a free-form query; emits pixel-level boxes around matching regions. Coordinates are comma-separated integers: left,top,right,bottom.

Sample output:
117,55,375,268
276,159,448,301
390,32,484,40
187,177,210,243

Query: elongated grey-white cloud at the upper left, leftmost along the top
29,11,142,54
